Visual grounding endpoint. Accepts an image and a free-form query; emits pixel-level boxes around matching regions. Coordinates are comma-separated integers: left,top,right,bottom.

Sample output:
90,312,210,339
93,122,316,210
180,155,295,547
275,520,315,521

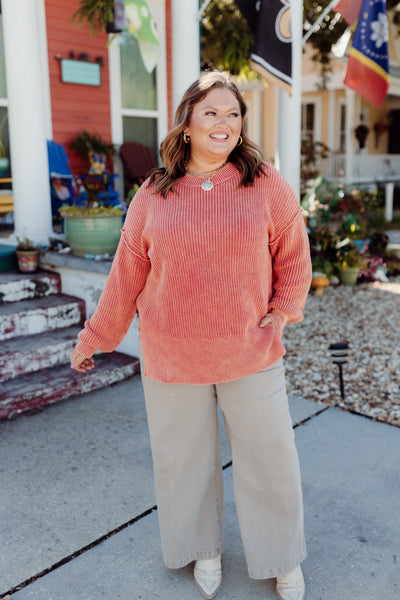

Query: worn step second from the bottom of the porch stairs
0,327,81,382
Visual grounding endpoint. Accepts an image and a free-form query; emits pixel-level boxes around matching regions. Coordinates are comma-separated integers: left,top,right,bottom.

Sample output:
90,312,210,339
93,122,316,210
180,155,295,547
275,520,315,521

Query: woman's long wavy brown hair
148,71,264,197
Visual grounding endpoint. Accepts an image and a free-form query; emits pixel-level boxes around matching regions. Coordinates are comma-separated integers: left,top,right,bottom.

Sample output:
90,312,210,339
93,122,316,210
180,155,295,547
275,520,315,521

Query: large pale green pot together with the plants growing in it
59,174,124,257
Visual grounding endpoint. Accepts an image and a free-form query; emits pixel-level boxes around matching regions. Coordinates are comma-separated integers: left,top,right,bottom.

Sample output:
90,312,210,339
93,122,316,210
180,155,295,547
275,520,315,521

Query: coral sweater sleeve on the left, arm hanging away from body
76,192,150,357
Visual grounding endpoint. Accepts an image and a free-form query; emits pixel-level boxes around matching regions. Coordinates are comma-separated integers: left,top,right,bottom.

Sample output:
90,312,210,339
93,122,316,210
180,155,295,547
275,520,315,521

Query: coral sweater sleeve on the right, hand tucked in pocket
268,169,312,332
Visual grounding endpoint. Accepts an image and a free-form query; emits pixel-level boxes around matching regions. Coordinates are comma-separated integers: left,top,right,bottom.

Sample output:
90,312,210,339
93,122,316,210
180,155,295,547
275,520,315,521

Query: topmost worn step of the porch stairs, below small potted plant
0,271,61,302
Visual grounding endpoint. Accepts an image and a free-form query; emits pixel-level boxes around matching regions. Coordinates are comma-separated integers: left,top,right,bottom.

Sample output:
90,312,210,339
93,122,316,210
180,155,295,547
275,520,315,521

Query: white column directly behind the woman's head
172,0,200,112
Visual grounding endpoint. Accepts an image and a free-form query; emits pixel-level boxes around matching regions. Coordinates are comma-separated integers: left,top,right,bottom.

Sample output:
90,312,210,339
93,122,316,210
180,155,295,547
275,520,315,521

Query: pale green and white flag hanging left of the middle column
124,0,161,73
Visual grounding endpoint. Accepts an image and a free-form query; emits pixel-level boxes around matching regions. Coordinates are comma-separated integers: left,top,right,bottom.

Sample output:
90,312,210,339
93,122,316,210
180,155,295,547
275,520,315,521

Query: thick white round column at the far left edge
1,0,53,244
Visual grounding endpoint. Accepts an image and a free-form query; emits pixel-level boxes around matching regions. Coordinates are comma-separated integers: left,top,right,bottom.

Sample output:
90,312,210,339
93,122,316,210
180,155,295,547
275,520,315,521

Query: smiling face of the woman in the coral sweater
184,88,242,163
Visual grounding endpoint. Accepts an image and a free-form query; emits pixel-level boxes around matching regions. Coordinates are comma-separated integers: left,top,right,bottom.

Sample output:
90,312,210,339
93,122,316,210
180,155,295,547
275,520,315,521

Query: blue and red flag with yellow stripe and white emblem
344,0,390,106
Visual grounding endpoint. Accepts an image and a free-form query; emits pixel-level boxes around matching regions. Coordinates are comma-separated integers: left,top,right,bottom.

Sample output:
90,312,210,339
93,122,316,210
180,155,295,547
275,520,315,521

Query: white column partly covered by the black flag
278,1,303,198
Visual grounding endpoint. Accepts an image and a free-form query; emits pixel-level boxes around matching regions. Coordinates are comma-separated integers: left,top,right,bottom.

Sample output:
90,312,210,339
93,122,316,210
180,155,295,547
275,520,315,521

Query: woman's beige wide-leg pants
142,360,306,579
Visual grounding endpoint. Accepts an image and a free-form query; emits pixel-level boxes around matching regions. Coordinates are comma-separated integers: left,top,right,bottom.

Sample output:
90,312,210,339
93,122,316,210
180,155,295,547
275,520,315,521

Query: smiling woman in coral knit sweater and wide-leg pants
72,72,311,600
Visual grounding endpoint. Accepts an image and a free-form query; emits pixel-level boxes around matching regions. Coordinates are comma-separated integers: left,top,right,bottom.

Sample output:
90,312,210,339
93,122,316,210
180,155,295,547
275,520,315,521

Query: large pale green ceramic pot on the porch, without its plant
65,215,122,256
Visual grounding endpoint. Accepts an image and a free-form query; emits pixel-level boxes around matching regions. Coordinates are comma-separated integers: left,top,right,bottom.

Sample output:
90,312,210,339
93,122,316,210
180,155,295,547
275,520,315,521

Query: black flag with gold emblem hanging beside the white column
236,0,292,91
